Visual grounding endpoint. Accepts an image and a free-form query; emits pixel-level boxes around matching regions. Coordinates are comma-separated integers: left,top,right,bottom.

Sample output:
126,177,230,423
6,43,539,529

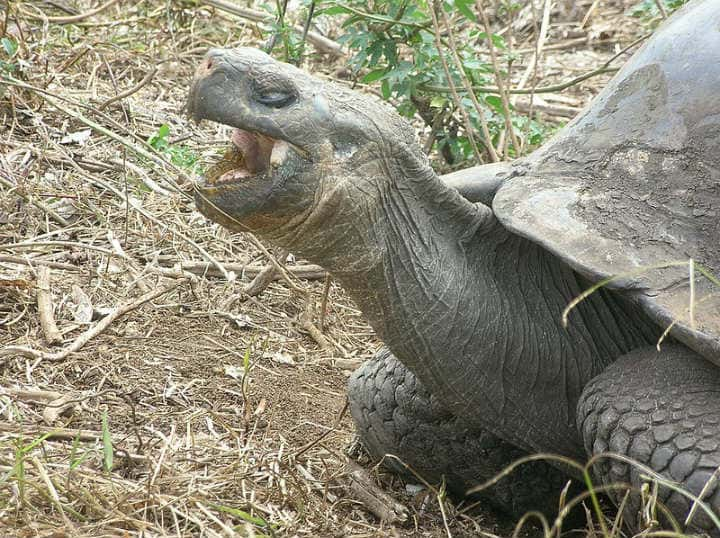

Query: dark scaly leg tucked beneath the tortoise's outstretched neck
348,348,580,522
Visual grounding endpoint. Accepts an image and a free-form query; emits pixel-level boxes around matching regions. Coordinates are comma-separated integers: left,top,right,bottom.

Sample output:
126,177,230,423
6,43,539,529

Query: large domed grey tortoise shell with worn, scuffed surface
493,0,720,365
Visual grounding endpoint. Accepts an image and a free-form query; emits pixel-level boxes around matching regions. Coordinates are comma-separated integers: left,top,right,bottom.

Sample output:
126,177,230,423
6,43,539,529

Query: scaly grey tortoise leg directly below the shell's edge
578,345,720,536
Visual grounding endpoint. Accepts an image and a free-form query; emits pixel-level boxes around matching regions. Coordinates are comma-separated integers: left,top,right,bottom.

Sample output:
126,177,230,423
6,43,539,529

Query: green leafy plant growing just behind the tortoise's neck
321,0,548,164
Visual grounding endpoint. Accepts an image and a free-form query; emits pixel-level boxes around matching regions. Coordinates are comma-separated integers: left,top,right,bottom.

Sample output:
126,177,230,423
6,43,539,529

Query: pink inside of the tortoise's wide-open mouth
204,128,290,186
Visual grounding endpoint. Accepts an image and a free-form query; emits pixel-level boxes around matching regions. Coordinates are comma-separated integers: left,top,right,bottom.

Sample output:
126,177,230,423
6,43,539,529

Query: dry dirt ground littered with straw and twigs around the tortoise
0,0,660,538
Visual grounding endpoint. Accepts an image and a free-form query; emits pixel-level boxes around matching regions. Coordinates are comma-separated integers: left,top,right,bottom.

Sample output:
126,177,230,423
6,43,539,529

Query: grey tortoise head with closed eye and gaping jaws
188,48,424,238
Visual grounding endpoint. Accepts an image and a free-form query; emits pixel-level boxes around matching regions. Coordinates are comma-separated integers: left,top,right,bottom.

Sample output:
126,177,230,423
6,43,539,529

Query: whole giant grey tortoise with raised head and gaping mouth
188,0,720,533
